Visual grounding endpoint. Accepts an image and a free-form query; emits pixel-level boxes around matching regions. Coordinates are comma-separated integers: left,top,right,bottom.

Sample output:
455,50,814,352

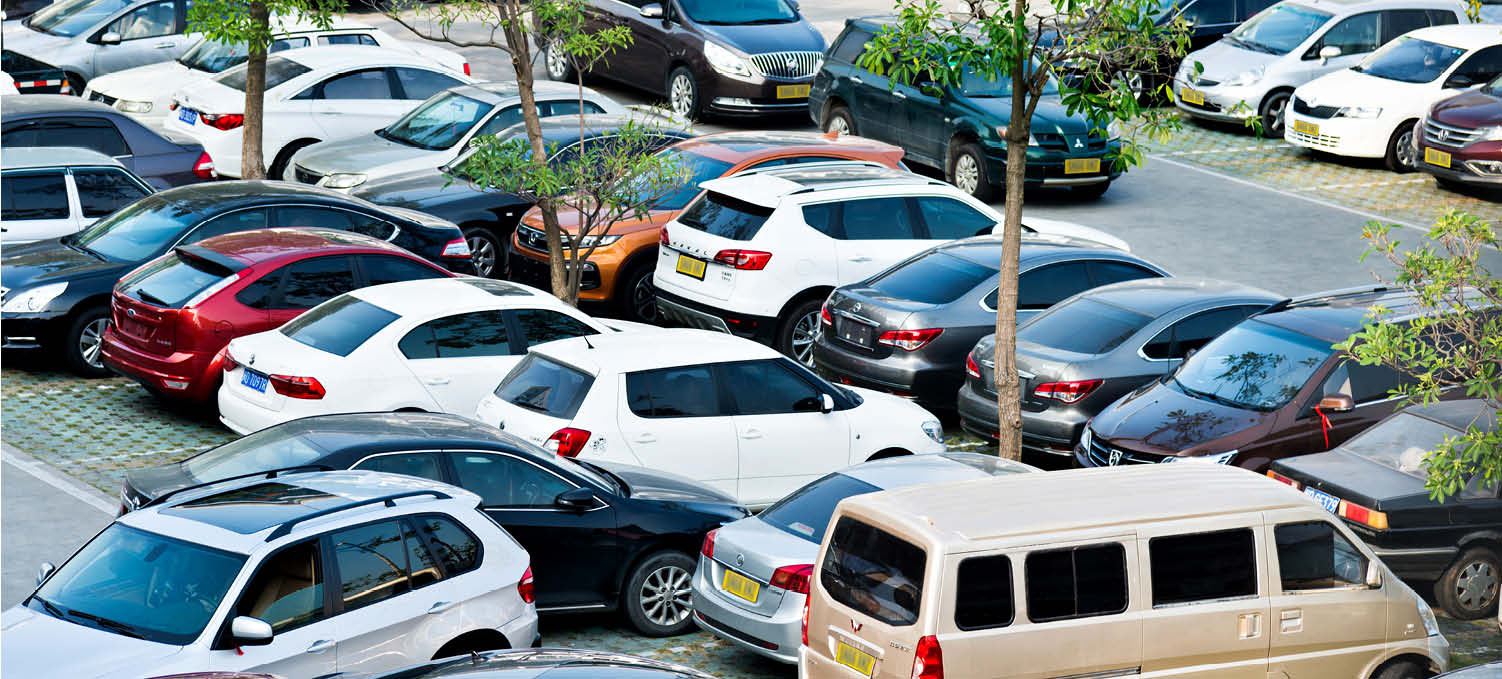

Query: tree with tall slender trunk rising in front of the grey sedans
859,0,1188,460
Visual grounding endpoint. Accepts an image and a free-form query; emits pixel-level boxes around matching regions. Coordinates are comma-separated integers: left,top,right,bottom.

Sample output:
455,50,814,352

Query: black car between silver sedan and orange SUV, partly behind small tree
350,114,692,278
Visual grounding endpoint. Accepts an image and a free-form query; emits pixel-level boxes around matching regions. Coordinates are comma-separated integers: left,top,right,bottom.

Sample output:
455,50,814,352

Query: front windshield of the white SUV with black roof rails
27,523,245,646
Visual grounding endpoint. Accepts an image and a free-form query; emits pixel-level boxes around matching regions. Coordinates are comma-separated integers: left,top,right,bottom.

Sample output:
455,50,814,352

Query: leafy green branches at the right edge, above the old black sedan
1335,210,1502,502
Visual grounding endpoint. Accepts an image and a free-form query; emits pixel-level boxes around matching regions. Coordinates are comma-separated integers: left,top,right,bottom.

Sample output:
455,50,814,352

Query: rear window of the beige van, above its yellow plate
819,517,925,625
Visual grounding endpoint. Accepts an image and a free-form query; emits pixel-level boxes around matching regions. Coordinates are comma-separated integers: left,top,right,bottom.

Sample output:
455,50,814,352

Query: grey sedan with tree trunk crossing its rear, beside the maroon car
957,278,1283,460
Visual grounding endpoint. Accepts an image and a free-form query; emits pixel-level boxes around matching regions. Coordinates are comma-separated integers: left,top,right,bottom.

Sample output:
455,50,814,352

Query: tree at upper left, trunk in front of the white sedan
188,0,344,179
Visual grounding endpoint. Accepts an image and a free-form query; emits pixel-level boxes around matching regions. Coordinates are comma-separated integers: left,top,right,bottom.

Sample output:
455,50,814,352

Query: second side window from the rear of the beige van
1023,542,1127,622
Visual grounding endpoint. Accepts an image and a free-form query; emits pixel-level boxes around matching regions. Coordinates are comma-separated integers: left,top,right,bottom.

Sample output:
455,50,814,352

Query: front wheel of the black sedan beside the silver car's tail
620,551,698,637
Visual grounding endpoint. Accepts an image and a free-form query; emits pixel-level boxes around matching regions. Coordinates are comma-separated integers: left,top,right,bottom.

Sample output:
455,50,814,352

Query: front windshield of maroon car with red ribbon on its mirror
1173,320,1334,412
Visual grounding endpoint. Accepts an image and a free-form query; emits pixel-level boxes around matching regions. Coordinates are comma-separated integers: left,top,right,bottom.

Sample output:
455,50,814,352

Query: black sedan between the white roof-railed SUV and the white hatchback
120,413,749,635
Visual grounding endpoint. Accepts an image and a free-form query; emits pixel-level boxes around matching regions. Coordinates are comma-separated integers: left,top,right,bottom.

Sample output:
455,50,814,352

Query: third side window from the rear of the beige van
1148,529,1257,605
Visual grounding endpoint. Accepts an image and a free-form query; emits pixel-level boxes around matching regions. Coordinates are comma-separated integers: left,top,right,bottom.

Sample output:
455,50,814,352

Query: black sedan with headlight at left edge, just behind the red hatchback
0,182,473,377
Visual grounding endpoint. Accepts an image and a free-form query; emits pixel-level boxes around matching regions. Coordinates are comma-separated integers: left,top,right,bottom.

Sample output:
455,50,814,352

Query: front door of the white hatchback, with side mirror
719,358,850,505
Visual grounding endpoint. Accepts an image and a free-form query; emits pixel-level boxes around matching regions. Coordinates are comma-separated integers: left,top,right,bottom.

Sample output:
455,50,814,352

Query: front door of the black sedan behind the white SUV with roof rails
448,451,620,608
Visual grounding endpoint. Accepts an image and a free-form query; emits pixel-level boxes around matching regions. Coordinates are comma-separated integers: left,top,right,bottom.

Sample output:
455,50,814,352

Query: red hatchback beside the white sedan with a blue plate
101,228,454,403
